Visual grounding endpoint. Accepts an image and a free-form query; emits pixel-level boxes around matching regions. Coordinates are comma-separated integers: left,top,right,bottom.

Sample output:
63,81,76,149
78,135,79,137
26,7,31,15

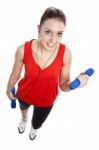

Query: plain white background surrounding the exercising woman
0,0,99,150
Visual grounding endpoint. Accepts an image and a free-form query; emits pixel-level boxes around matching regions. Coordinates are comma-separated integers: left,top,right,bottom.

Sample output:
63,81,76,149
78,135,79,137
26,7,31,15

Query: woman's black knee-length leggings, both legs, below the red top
18,99,53,129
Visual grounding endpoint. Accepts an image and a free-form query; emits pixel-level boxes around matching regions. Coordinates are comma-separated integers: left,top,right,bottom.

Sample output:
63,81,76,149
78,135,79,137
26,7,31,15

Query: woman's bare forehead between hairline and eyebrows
41,18,65,31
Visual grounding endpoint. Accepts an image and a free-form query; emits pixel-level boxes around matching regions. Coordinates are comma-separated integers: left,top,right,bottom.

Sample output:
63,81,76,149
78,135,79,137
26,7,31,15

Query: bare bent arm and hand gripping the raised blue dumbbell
59,49,89,92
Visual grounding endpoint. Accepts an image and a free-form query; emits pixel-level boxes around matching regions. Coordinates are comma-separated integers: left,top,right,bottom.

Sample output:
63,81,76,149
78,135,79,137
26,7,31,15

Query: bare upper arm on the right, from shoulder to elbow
59,49,72,91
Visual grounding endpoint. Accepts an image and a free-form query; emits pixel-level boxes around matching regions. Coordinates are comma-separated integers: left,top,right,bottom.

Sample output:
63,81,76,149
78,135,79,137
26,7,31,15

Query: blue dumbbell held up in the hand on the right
69,68,94,90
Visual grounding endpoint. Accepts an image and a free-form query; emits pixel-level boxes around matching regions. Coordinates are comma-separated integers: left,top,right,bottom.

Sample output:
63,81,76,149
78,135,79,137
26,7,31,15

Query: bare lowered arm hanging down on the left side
6,45,24,99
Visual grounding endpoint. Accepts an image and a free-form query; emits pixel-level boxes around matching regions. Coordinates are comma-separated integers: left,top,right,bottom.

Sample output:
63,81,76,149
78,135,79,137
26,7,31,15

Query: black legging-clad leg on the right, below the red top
32,105,53,129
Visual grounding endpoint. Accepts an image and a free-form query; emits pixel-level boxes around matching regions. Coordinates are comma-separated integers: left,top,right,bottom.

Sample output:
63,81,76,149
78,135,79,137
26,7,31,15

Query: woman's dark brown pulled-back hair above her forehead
40,7,66,26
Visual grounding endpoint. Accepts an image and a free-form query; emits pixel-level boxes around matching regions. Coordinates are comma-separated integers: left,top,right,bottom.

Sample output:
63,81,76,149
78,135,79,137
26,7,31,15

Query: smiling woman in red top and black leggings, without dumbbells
7,7,88,140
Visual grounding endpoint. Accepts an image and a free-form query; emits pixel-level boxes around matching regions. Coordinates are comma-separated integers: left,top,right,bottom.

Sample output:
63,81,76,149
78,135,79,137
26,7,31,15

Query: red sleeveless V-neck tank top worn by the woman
16,40,65,107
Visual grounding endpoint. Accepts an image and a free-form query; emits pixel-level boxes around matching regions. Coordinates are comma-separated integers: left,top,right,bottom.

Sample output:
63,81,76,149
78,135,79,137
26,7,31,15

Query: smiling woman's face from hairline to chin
39,19,65,50
